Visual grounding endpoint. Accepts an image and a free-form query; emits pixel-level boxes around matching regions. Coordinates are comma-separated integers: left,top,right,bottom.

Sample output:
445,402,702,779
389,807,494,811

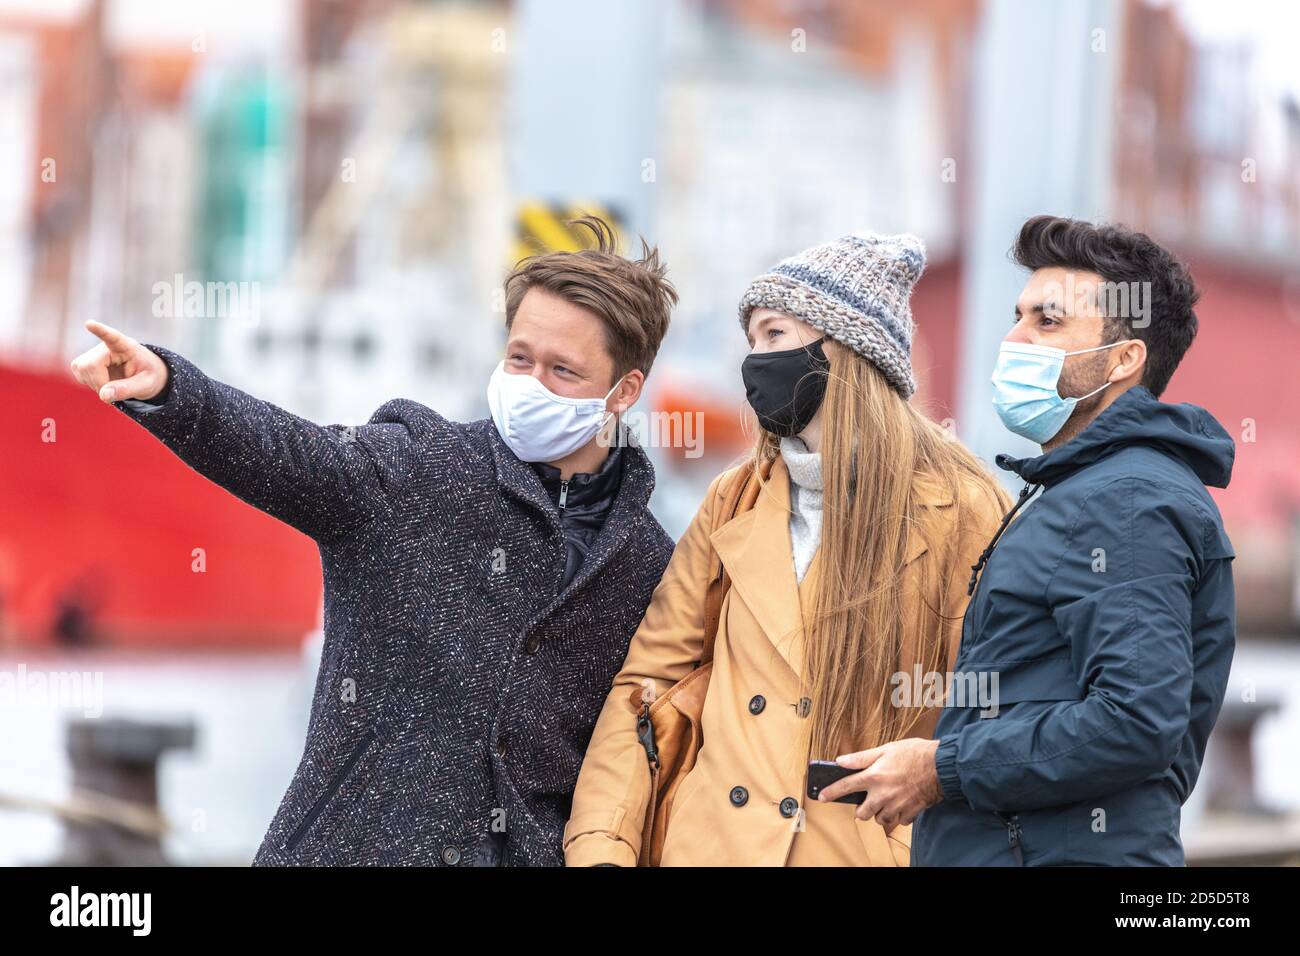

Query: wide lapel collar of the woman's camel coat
710,457,953,676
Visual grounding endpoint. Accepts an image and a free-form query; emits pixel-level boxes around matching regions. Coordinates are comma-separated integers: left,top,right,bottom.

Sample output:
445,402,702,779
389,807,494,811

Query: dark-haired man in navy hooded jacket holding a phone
823,216,1235,866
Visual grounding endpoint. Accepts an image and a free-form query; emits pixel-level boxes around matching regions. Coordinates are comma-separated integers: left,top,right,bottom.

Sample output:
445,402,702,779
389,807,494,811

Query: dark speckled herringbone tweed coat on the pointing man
117,346,672,866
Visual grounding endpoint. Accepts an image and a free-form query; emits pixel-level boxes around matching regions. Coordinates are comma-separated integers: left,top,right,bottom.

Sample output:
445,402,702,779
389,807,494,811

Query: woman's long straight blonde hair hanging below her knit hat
754,346,1009,760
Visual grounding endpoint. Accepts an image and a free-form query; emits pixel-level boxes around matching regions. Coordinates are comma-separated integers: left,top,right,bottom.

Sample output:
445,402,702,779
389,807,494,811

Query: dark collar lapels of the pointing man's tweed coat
488,421,654,620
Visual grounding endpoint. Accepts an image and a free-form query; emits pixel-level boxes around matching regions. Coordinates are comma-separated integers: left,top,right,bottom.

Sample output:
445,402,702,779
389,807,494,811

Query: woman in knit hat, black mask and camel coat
564,234,1006,866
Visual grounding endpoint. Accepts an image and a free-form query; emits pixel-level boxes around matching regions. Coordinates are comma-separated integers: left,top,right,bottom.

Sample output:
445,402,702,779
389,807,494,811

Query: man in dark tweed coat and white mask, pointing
73,219,677,866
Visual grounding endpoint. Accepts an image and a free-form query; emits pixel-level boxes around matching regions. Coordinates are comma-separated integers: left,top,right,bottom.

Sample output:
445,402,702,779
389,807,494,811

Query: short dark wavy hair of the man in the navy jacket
1011,216,1200,398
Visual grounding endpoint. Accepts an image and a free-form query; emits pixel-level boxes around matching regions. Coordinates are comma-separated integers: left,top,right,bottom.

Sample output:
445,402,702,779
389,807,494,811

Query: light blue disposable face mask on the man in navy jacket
993,338,1130,445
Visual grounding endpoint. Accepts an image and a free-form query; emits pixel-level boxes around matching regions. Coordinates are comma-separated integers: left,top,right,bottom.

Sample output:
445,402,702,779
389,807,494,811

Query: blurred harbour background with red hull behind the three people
0,0,1300,864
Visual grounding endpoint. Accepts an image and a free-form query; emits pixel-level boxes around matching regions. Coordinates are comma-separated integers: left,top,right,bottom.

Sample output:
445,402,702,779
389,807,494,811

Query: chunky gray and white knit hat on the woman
740,233,926,398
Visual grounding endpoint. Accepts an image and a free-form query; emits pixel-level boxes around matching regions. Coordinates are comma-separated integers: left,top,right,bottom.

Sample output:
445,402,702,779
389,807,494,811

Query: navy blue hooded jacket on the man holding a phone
911,386,1236,866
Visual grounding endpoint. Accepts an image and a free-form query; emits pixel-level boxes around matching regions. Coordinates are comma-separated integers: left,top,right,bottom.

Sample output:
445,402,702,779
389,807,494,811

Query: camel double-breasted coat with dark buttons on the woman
564,458,1000,866
